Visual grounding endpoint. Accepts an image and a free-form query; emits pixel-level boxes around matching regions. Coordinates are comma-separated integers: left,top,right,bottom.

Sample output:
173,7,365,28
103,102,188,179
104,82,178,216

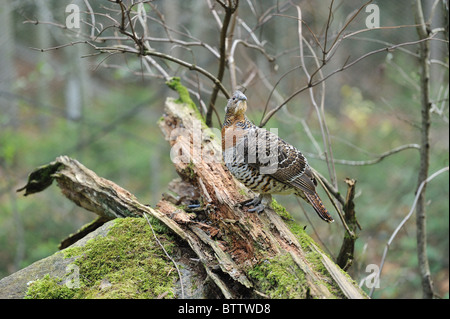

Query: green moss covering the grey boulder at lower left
28,218,178,298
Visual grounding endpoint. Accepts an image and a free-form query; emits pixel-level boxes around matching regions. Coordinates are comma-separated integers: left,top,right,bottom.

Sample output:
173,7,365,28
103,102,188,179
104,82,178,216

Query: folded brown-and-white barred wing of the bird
244,128,317,194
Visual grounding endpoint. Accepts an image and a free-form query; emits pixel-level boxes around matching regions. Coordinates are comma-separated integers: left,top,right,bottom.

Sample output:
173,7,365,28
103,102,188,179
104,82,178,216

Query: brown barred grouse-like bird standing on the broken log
222,91,334,222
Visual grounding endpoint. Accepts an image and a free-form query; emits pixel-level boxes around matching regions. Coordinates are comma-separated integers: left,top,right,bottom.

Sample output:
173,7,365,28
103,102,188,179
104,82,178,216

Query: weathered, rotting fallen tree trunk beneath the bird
15,99,367,298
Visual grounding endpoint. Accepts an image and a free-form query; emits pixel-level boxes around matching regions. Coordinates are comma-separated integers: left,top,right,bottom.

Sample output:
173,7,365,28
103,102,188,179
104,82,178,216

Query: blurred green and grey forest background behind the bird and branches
0,0,449,298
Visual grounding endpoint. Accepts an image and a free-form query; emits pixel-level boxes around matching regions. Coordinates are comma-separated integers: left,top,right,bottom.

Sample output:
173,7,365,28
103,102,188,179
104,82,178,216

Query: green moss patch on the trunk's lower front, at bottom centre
248,254,308,299
